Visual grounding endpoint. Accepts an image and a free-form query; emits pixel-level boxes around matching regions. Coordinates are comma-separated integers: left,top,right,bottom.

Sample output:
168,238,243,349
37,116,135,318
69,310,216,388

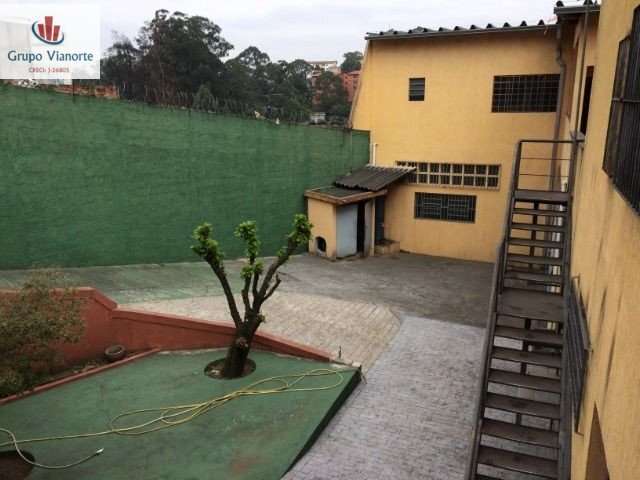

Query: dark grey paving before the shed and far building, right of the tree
281,253,493,327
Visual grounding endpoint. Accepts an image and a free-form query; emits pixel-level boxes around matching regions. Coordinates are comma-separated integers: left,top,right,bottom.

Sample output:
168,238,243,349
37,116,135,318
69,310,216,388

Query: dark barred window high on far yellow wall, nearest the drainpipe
491,74,560,113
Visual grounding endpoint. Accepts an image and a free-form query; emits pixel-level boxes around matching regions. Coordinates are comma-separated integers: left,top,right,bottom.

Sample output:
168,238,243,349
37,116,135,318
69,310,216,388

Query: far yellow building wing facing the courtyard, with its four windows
351,17,560,261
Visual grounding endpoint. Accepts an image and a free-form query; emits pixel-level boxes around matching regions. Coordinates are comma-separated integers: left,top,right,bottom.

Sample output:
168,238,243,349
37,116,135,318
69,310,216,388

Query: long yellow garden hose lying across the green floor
0,368,354,470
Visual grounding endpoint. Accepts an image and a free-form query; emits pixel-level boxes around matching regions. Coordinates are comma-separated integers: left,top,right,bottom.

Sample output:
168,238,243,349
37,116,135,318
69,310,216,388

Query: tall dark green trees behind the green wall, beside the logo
102,14,312,120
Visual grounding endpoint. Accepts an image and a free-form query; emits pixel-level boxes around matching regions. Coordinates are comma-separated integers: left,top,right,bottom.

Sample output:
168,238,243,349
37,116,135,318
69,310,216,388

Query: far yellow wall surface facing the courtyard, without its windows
352,30,559,261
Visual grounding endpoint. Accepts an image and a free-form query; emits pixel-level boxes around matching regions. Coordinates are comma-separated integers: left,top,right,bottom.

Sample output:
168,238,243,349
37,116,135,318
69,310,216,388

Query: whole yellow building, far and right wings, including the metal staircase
310,0,640,480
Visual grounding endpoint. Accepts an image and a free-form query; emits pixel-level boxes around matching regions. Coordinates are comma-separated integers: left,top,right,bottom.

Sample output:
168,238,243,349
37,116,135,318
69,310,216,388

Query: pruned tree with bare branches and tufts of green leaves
191,214,313,378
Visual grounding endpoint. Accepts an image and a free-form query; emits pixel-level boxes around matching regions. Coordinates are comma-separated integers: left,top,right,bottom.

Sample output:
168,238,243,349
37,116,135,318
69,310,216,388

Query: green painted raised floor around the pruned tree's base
0,351,355,480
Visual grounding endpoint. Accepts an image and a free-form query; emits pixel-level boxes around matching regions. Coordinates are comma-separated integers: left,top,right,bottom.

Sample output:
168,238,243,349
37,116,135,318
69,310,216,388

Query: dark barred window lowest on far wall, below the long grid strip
414,192,476,223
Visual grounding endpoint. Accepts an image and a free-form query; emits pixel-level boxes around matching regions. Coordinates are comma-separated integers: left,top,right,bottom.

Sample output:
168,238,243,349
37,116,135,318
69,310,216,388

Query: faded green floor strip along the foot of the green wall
0,260,242,304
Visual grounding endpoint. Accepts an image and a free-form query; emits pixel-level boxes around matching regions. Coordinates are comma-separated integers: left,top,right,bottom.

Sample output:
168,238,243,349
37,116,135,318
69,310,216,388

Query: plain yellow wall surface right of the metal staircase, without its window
572,0,640,480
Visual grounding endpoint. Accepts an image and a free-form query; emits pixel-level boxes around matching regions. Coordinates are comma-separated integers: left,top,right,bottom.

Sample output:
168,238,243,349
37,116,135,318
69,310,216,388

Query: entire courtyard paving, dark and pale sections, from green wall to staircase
0,254,492,480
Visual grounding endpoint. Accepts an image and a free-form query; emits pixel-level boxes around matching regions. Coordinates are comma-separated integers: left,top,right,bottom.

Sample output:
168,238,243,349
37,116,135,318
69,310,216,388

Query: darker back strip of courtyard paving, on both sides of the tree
0,253,492,326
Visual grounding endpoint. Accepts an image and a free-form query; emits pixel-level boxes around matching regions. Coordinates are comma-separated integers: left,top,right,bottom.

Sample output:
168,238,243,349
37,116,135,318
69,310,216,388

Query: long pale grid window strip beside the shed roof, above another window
396,162,500,189
